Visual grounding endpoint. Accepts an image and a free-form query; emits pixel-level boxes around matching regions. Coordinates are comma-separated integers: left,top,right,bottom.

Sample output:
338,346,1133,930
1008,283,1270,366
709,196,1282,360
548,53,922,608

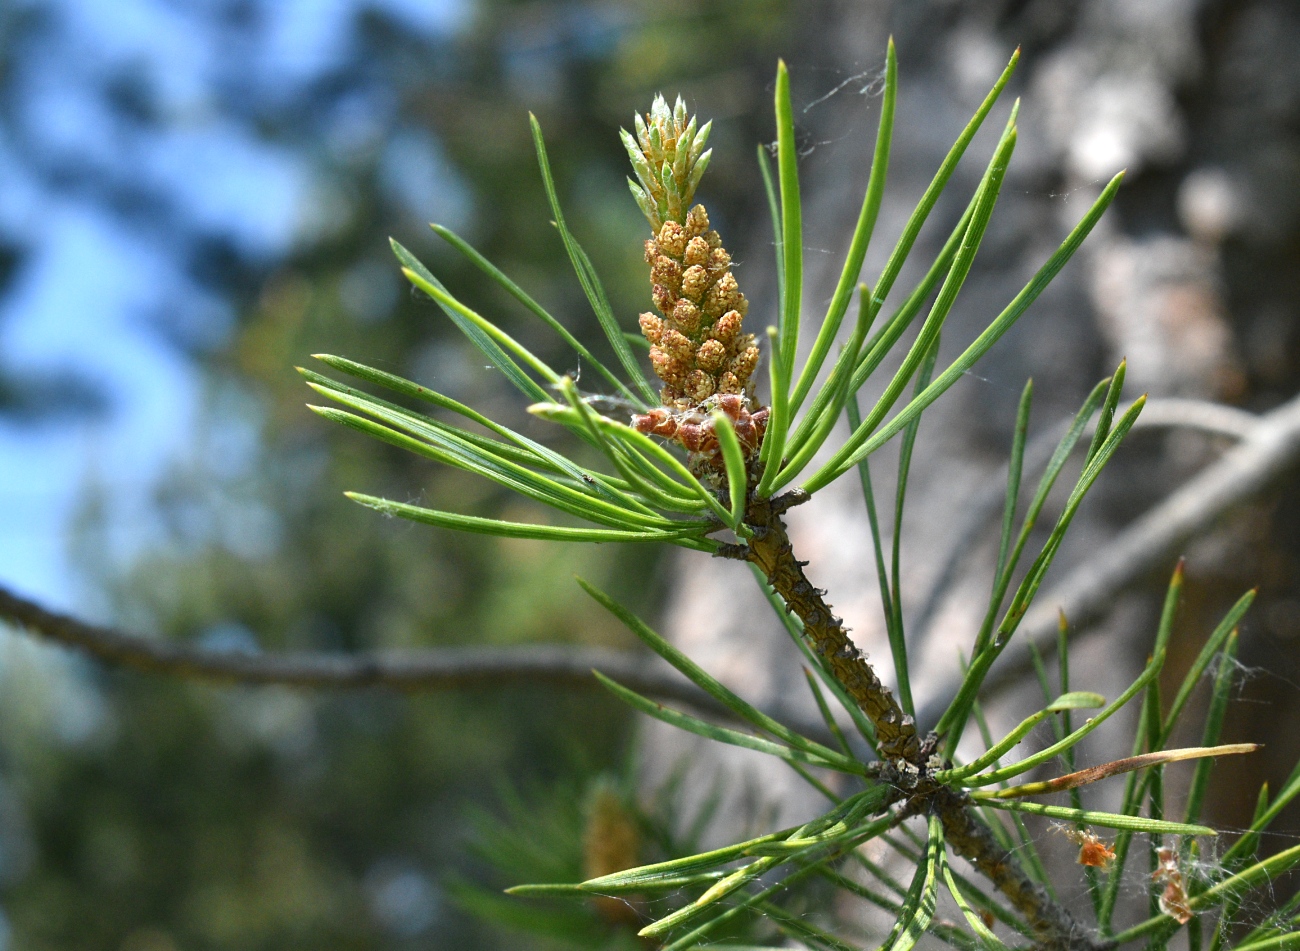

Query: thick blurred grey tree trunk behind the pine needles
645,0,1300,893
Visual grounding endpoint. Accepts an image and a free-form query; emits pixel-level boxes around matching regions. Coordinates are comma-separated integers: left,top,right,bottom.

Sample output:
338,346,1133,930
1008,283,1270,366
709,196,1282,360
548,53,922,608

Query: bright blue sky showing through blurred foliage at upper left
0,0,473,613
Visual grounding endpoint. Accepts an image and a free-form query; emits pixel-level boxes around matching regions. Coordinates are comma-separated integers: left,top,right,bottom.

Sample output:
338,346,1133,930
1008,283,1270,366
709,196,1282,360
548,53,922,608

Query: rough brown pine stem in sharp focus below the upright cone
738,498,1114,951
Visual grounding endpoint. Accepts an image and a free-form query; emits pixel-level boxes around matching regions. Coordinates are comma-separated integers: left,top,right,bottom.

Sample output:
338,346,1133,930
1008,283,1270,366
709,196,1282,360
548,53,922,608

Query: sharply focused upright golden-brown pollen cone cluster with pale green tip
623,96,768,468
